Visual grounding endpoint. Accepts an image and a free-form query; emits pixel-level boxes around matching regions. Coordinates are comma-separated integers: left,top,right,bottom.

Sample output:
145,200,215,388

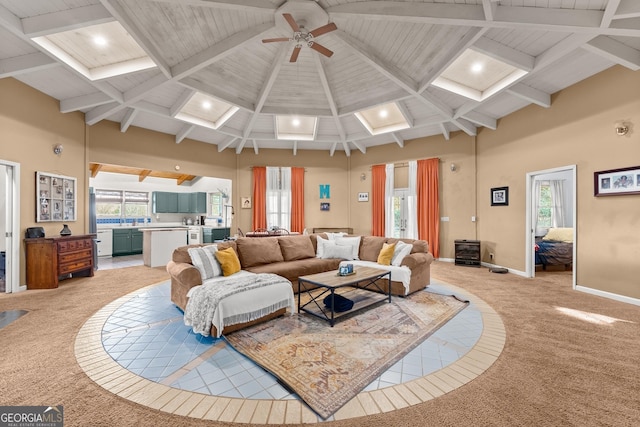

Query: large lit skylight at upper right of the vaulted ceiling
433,49,527,102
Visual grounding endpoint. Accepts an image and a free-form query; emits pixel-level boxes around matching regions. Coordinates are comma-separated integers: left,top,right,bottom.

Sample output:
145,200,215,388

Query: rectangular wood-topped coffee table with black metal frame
298,267,391,327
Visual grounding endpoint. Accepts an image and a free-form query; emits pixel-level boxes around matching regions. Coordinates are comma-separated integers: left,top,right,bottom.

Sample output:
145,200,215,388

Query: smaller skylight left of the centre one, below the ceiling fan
175,92,239,129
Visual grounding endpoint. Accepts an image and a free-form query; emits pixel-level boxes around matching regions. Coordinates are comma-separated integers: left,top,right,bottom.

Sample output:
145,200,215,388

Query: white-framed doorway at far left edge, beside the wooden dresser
0,159,21,293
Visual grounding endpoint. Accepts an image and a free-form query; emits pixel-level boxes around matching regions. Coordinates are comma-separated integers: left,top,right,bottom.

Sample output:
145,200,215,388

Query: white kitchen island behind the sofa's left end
139,227,187,267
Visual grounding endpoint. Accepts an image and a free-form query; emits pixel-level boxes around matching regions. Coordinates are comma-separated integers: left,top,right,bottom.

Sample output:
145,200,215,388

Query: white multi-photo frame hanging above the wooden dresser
36,172,77,222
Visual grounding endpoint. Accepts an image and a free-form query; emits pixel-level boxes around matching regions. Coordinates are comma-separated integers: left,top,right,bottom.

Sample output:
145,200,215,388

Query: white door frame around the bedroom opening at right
525,165,578,289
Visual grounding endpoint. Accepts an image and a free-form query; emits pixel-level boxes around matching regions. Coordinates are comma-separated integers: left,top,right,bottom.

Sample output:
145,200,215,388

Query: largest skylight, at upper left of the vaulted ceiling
32,21,156,80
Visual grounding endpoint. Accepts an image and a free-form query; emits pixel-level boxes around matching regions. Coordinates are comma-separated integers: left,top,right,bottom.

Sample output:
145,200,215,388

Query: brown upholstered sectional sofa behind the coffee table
167,233,433,314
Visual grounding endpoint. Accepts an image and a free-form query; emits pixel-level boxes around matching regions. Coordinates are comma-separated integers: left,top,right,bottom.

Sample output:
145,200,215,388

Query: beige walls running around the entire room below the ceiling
0,67,640,298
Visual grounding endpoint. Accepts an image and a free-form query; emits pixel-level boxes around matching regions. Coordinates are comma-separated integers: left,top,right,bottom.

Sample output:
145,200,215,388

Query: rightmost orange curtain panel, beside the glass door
417,158,440,258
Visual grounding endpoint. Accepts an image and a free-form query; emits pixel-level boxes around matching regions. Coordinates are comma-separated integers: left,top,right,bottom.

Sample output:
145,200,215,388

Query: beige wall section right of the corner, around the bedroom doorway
477,67,640,298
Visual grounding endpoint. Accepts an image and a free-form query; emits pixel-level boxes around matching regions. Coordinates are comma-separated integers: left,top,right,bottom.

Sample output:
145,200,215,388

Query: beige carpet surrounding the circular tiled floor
0,262,640,427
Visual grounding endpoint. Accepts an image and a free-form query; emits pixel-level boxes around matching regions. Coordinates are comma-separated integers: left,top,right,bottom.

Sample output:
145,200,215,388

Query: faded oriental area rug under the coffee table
226,291,468,419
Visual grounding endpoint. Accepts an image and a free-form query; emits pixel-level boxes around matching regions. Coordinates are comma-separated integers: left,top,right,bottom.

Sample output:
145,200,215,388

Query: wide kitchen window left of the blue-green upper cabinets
96,190,149,218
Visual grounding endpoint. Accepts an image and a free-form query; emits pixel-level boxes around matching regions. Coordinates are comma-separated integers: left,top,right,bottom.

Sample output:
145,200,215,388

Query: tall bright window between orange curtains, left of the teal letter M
267,167,291,230
